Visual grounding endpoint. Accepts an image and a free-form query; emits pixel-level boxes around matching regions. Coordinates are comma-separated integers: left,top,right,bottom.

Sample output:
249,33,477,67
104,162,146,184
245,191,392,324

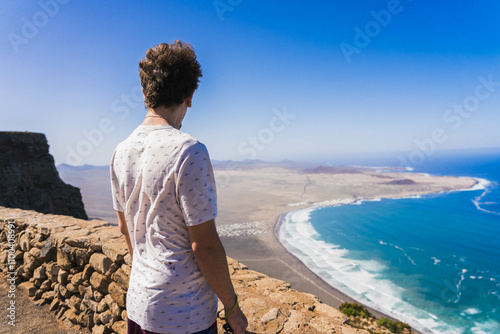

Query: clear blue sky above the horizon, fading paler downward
0,0,500,165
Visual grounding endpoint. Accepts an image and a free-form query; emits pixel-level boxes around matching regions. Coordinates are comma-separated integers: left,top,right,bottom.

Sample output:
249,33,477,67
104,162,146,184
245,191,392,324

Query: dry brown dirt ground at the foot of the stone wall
0,275,90,334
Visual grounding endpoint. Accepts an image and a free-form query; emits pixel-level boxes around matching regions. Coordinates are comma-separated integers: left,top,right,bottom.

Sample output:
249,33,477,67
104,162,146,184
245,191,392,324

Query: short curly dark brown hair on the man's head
139,40,202,108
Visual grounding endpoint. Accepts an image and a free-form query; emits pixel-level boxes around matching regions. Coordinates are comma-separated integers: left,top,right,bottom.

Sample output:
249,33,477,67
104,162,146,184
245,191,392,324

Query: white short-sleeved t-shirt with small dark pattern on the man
110,125,217,334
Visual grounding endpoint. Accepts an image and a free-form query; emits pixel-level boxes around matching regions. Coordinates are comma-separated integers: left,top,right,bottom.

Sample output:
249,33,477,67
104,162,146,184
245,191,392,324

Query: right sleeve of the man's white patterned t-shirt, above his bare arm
176,142,217,226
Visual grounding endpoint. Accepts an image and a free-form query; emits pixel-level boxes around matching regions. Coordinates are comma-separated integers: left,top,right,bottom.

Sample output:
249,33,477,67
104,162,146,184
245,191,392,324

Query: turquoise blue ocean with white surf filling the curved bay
279,150,500,333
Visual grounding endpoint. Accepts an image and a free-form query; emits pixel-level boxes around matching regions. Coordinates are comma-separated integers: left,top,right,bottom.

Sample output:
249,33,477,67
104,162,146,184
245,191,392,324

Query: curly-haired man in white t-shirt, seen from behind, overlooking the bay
110,41,247,334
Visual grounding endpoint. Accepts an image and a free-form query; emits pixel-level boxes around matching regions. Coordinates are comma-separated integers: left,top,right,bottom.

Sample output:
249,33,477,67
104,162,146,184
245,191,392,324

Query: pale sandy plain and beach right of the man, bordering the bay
215,167,477,322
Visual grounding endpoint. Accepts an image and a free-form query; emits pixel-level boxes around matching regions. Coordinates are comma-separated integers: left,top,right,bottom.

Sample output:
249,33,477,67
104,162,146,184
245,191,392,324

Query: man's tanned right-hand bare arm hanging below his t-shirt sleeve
188,219,248,334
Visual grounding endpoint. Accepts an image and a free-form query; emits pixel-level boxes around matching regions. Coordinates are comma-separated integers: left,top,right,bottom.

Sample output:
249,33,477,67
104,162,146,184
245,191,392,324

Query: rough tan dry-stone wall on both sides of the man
0,207,368,334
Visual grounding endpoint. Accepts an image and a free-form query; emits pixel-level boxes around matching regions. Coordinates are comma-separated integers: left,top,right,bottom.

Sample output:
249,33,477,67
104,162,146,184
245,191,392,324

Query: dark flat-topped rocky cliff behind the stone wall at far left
0,132,87,219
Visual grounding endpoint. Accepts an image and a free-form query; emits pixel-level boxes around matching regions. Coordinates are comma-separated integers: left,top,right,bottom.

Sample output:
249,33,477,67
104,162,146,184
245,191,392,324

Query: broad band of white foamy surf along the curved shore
278,208,465,334
